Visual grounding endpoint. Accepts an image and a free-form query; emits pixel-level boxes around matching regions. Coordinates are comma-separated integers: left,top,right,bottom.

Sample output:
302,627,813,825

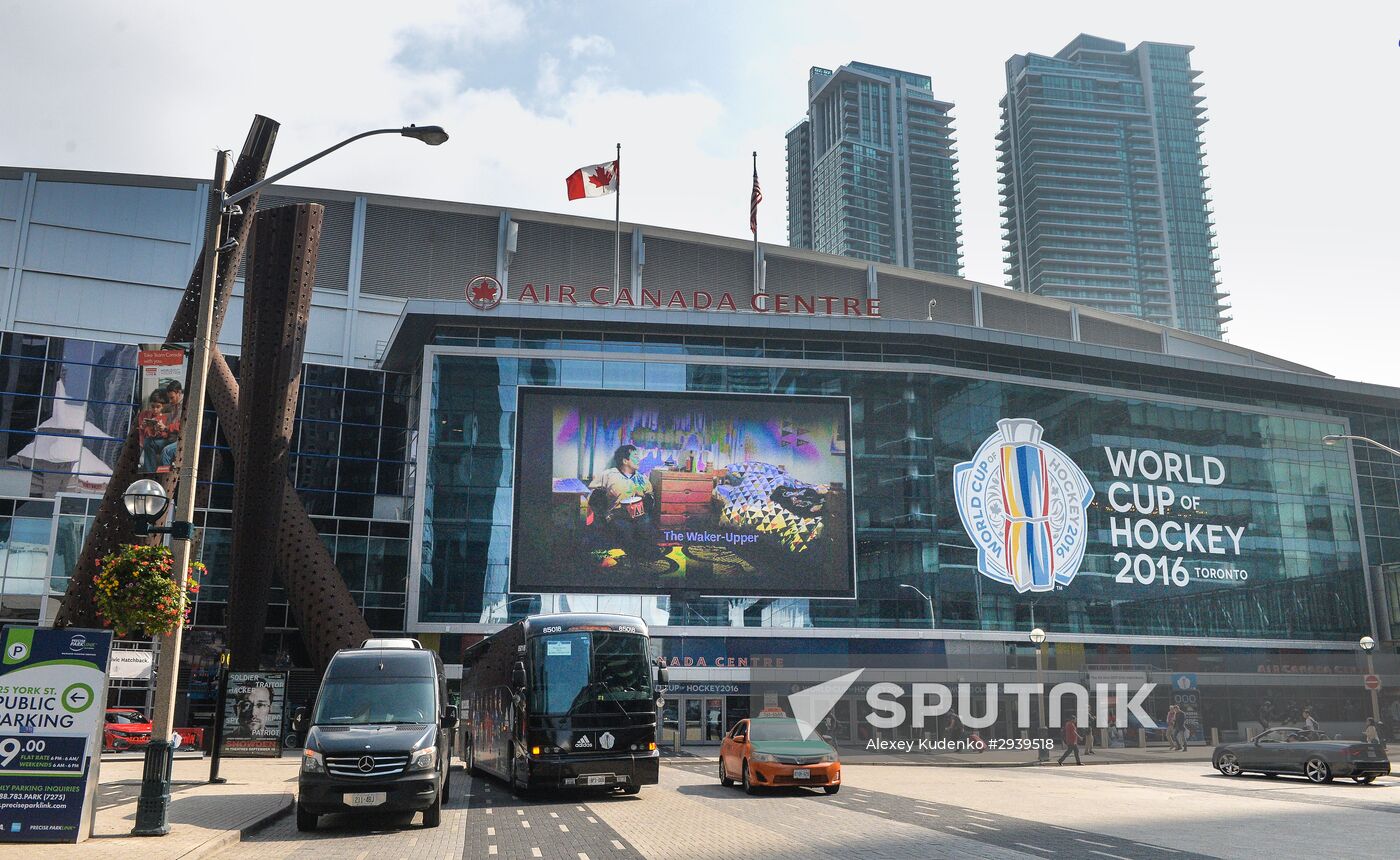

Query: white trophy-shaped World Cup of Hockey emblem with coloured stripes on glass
953,417,1093,592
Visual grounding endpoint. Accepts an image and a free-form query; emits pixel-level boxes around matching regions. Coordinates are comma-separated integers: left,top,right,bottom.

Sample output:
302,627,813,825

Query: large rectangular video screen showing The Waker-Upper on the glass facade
511,387,855,598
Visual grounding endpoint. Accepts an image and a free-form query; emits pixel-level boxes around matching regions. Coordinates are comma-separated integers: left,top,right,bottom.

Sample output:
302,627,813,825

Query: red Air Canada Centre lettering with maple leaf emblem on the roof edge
468,276,881,318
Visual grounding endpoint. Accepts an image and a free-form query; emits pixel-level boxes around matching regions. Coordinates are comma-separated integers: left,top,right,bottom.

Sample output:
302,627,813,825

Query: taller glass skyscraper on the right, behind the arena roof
998,35,1229,338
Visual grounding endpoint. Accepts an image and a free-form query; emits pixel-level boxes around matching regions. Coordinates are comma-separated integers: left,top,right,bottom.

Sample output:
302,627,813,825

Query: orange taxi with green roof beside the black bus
720,716,841,794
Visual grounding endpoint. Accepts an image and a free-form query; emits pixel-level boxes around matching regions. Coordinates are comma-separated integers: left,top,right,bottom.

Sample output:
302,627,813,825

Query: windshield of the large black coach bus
529,632,652,714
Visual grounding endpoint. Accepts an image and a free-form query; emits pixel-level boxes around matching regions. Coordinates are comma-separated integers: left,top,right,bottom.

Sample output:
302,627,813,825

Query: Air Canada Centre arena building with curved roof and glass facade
0,168,1400,742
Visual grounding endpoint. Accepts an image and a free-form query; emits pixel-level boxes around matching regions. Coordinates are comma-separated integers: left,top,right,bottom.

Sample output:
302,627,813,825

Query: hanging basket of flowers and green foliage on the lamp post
92,545,204,636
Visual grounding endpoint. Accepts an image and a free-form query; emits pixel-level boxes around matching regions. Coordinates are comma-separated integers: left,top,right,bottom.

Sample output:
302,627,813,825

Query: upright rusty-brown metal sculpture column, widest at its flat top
225,203,325,671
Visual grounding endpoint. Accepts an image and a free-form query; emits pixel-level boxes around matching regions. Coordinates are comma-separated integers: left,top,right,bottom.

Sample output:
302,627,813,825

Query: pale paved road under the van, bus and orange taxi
230,758,1400,860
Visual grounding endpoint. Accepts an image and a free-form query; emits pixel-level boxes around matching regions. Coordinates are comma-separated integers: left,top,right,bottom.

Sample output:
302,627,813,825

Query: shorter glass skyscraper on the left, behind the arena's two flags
787,63,962,276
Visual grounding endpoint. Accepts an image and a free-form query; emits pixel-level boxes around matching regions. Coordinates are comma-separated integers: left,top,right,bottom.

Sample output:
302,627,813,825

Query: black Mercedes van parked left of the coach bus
297,641,456,831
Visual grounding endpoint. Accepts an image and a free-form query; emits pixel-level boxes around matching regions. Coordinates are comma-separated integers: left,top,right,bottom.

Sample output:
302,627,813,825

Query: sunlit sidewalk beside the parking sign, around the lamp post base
4,755,301,860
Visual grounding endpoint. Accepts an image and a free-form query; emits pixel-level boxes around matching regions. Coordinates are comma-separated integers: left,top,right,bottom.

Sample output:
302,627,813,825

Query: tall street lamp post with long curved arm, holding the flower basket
123,126,448,836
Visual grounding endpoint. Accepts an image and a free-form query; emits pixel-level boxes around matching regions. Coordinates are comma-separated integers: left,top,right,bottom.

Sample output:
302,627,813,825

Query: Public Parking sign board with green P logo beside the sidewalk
0,626,112,843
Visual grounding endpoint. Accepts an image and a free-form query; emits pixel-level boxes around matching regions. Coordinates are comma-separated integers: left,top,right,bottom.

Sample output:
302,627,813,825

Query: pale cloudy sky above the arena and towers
0,0,1400,385
